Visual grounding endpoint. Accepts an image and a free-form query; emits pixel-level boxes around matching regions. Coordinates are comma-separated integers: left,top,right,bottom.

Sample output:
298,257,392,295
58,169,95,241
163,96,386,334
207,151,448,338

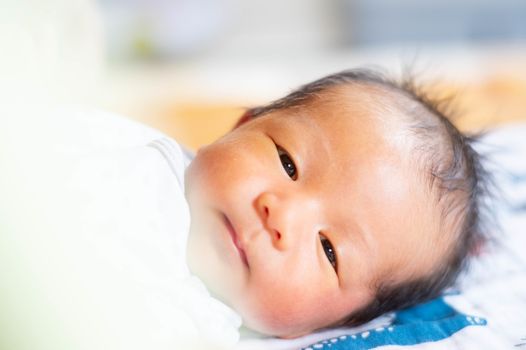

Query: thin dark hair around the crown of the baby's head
246,69,491,326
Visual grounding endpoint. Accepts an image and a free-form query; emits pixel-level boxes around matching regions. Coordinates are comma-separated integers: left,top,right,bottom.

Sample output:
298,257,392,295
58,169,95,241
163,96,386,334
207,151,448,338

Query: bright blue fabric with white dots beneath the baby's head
304,297,487,350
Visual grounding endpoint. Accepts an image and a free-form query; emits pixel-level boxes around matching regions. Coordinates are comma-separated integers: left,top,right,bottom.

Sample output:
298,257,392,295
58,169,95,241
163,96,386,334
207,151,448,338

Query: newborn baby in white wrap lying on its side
0,70,484,349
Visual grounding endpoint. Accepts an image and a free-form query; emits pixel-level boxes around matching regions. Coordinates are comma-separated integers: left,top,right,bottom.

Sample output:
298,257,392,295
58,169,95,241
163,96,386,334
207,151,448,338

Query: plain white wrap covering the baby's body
0,111,241,349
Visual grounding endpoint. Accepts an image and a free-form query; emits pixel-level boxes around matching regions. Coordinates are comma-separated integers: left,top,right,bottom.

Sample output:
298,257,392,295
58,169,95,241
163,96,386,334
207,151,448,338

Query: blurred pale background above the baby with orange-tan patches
2,0,526,148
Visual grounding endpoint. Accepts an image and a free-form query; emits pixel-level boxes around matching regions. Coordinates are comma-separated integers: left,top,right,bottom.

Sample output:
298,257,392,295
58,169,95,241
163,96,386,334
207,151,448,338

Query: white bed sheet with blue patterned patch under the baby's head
236,124,526,350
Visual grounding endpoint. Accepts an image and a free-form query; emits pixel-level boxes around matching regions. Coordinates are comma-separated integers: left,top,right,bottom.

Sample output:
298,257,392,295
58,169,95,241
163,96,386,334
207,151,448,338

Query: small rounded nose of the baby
255,192,318,250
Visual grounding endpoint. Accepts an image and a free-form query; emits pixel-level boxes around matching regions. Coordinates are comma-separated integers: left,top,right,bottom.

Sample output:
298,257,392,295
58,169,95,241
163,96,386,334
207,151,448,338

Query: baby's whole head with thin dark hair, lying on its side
186,70,490,337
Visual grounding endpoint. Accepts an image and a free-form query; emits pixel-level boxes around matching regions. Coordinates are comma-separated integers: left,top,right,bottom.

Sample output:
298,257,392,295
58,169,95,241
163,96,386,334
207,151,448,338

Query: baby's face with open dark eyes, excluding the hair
186,86,442,336
